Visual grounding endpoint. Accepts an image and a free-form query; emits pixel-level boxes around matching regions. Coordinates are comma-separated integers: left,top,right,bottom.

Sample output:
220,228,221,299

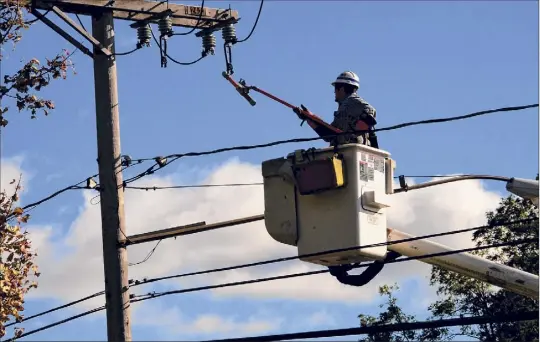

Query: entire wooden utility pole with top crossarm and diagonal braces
6,0,239,342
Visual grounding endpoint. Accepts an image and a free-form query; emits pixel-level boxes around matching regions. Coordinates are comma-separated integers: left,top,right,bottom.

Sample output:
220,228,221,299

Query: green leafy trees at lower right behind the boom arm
359,196,539,342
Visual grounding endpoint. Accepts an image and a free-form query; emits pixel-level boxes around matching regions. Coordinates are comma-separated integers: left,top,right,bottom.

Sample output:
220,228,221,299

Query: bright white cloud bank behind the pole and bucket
20,156,499,307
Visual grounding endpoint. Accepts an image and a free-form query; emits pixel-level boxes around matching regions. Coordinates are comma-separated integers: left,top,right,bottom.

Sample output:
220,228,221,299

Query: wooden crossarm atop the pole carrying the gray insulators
28,0,239,28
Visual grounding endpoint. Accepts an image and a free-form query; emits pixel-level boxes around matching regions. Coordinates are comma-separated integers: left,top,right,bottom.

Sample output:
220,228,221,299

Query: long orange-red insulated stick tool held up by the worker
222,72,342,136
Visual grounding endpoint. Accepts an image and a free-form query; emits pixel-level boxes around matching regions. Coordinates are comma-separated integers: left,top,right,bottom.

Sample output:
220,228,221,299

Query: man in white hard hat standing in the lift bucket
294,71,379,148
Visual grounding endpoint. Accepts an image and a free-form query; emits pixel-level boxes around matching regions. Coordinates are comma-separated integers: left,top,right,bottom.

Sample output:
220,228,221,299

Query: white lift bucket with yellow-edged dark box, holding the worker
262,144,394,266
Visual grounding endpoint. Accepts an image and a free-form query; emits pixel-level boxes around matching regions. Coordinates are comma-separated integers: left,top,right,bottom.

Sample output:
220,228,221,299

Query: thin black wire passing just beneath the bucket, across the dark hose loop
10,239,538,338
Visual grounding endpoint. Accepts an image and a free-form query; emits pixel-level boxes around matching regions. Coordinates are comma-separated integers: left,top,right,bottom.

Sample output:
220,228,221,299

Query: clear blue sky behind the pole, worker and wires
2,1,539,340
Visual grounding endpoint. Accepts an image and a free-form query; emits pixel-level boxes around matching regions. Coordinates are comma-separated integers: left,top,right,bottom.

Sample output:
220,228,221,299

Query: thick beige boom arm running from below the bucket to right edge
388,228,539,300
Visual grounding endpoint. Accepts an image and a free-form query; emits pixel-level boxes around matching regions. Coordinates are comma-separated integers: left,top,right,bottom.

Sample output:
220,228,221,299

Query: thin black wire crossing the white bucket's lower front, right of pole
126,218,538,287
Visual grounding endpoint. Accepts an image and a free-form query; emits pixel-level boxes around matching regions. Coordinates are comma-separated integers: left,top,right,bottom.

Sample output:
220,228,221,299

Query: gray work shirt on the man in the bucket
331,93,377,146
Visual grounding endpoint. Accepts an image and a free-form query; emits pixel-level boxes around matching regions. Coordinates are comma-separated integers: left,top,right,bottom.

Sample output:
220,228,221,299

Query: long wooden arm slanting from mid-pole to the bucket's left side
124,215,264,246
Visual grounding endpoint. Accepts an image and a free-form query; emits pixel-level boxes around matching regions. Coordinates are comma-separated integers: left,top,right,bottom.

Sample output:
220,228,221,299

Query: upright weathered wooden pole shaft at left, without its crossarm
92,11,131,342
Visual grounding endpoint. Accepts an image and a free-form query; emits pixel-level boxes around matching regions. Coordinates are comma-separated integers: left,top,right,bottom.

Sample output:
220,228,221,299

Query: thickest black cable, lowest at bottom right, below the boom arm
200,311,538,342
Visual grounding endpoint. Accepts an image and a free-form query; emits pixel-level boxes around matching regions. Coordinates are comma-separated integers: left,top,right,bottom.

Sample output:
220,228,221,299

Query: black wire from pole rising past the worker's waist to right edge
125,103,538,184
